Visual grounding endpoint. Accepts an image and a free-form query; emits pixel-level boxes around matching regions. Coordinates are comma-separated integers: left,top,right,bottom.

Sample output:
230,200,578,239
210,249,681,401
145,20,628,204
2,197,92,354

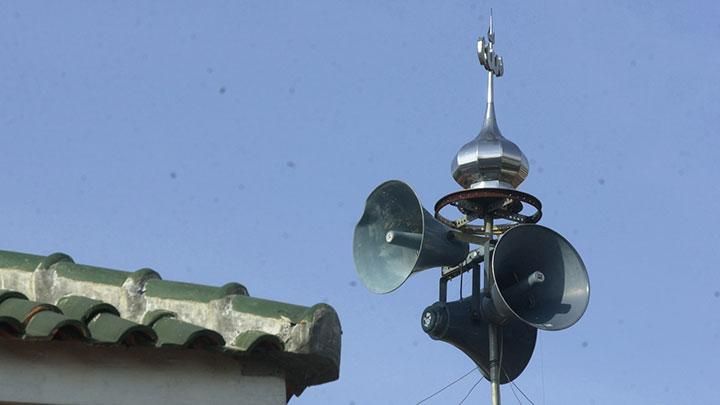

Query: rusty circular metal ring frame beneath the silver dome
435,188,542,234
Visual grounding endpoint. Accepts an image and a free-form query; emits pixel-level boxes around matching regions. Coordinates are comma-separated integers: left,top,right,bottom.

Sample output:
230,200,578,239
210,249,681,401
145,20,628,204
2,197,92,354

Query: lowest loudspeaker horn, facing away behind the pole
420,299,537,384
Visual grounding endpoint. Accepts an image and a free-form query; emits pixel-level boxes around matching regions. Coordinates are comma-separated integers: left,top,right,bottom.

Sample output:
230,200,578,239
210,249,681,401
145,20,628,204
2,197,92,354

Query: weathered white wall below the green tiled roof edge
0,339,286,405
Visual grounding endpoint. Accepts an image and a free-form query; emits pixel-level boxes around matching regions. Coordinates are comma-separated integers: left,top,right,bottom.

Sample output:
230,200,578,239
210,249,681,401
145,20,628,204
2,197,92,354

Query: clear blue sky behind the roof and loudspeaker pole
0,1,720,405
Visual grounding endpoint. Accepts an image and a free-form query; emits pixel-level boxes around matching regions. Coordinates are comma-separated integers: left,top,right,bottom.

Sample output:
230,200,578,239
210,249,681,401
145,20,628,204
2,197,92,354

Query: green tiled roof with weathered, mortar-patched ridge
0,250,341,398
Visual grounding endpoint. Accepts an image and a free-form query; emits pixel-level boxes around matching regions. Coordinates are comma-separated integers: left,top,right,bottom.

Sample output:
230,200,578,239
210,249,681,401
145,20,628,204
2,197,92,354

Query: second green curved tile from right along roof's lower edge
147,316,225,347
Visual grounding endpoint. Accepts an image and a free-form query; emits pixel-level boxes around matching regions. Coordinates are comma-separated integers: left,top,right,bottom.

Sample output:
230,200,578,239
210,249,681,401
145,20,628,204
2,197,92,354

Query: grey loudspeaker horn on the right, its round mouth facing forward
490,225,590,330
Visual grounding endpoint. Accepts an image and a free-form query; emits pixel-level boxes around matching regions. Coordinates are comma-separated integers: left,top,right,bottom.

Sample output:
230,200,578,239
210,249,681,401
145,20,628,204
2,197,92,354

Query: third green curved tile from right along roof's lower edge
88,313,158,346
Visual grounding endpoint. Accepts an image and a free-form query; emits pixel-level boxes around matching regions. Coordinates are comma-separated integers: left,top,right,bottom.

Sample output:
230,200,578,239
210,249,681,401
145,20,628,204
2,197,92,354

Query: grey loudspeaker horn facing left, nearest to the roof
353,180,469,294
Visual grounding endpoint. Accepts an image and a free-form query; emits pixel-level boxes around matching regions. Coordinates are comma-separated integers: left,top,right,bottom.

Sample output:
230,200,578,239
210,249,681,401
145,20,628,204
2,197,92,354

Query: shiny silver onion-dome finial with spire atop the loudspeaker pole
451,10,529,189
